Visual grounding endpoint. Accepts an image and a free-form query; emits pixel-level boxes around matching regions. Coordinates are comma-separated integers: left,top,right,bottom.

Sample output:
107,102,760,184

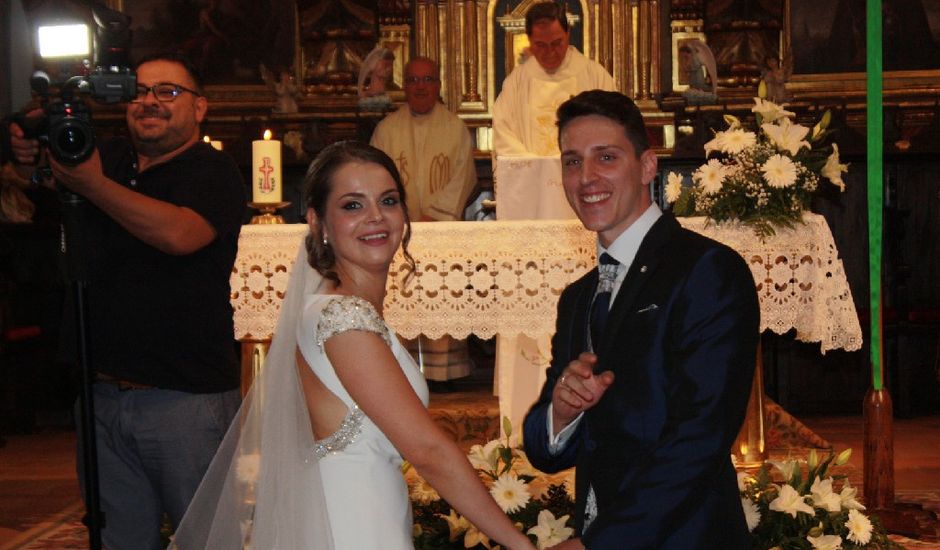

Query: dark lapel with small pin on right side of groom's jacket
595,212,681,358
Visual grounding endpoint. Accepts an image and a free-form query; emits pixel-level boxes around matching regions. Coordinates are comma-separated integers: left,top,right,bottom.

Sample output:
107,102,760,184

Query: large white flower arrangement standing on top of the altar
666,97,848,238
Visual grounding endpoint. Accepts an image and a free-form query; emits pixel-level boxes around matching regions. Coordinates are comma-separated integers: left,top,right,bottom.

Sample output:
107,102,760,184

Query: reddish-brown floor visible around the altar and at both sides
0,398,940,547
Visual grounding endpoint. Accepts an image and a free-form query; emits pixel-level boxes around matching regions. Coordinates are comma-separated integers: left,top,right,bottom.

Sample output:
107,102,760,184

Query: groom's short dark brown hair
556,90,650,157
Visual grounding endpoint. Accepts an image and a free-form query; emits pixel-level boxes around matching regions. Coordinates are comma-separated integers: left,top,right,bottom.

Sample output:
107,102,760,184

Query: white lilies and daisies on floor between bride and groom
403,418,574,550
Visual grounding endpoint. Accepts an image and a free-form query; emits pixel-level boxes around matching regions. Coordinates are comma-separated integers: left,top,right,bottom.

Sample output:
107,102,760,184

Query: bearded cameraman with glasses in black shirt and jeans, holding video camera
11,54,245,550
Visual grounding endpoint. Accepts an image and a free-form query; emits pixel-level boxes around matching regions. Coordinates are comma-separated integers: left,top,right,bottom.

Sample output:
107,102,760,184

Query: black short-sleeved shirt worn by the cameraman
84,140,245,393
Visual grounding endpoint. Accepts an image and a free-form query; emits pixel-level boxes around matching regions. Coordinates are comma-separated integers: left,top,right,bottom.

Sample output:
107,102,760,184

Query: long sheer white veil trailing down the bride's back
170,244,333,550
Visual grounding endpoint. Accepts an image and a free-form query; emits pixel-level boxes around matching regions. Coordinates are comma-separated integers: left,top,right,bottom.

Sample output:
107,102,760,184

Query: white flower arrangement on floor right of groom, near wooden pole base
738,449,901,550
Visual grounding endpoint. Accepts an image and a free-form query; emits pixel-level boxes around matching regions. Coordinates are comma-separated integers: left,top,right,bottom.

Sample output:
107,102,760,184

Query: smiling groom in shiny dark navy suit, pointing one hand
524,90,759,550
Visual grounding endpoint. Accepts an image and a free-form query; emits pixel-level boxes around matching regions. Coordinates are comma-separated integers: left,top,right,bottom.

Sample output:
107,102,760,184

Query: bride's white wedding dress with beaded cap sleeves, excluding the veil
297,294,428,550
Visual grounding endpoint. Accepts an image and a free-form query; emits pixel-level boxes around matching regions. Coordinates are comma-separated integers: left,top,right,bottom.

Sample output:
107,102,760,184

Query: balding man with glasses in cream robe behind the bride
371,57,477,390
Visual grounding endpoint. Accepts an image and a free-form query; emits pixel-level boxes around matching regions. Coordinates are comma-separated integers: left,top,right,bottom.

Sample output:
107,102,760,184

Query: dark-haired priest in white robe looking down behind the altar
493,2,615,440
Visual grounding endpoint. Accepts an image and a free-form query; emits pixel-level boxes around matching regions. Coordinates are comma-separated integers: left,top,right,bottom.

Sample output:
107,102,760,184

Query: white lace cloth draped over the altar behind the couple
231,214,862,353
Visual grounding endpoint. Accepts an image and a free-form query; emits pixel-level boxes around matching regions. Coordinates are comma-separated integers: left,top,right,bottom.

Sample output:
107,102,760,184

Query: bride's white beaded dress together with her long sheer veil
170,245,428,550
